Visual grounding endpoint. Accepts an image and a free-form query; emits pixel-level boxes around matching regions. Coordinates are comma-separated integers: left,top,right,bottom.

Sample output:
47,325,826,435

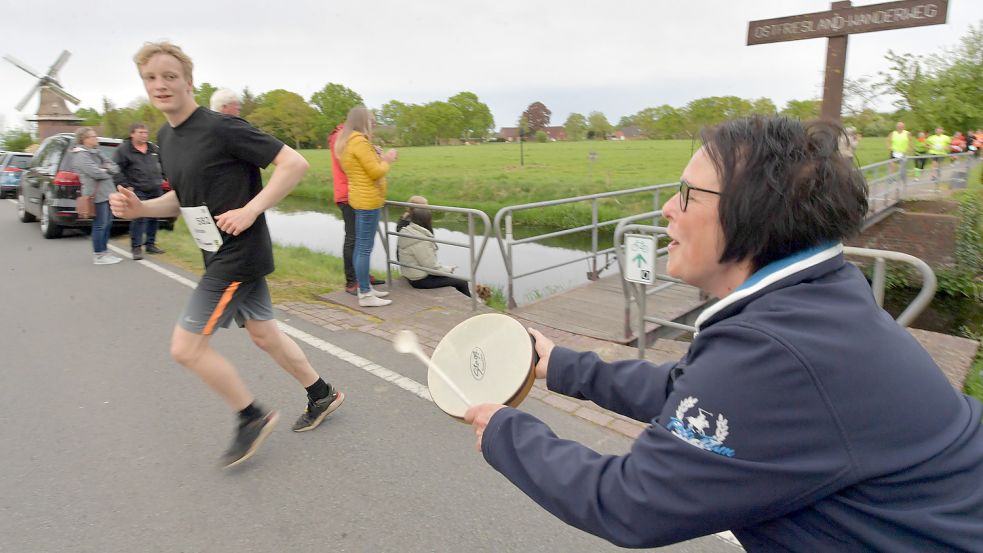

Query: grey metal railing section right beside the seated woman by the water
379,200,491,311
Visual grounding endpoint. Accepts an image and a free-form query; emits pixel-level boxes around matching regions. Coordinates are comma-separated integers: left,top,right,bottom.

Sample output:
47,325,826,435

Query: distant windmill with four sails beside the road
3,50,82,142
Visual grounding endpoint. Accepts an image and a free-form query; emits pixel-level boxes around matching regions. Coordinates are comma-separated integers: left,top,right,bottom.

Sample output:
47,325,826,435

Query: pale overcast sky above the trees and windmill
0,0,983,134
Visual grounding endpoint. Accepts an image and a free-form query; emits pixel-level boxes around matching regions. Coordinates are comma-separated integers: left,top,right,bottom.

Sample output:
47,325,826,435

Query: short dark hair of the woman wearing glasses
702,116,867,270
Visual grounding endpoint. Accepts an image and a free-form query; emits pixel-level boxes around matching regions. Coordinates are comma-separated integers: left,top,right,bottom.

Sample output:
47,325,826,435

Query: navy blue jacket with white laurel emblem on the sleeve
482,244,983,552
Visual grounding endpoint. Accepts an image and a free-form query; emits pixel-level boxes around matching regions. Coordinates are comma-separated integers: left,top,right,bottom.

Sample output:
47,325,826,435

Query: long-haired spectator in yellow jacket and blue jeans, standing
335,106,398,307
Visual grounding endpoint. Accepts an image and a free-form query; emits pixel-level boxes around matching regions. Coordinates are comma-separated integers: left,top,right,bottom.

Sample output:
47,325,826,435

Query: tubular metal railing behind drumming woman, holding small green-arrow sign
614,222,937,359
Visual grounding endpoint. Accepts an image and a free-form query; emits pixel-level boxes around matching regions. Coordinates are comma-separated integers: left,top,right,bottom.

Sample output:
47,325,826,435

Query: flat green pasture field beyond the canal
291,137,887,227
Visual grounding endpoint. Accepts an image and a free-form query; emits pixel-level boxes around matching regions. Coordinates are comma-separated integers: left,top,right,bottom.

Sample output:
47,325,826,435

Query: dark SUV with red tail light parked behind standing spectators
17,133,175,238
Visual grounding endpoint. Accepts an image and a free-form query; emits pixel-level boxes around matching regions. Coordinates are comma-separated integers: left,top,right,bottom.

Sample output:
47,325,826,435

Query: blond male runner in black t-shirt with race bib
110,42,345,467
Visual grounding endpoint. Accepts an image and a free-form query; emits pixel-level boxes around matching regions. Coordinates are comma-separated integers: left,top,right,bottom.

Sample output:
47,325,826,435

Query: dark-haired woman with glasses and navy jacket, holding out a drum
466,117,983,552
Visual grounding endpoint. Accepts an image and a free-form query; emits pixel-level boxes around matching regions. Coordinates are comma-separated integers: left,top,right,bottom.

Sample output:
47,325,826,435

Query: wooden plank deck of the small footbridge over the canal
510,257,706,344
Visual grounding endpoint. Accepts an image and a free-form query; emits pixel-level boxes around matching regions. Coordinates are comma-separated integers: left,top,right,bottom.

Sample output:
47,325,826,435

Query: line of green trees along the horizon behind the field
0,22,983,150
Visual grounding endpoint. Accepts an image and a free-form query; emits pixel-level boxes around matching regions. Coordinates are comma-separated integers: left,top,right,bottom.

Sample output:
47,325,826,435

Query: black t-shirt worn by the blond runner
157,107,283,282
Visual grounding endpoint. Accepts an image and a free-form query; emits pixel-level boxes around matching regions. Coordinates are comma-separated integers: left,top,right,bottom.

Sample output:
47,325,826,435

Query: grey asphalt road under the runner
0,201,738,553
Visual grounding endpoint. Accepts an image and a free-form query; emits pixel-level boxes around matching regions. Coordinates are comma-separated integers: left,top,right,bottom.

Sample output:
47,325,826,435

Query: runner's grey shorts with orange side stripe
178,276,273,336
